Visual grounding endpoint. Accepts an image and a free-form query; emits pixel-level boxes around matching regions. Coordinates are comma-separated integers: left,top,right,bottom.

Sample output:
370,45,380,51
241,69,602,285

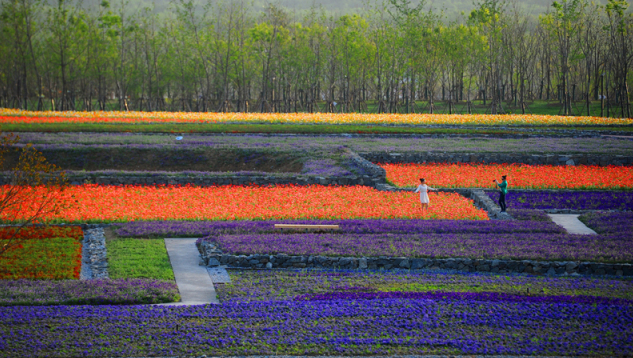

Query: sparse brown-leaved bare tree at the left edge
0,134,69,256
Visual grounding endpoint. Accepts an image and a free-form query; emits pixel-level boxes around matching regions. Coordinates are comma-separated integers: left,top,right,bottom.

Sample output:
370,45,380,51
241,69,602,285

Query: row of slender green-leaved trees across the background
0,0,633,117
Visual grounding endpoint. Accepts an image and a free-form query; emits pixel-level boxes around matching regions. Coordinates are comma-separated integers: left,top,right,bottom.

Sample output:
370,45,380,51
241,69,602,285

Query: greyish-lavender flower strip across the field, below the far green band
13,131,633,155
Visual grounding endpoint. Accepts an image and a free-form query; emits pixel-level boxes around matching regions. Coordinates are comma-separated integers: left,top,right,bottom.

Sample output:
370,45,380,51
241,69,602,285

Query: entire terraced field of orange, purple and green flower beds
0,109,633,358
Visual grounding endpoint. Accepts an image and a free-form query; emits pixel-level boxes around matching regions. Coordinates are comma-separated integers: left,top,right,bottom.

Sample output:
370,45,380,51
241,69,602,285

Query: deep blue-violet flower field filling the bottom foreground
0,300,633,357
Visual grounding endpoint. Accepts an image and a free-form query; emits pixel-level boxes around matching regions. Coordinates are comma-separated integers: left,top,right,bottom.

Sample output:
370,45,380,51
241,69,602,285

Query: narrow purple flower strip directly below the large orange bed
115,219,565,237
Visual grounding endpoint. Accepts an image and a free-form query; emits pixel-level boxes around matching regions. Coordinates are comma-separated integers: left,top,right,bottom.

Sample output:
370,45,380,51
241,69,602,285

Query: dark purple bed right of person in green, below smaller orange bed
487,190,633,211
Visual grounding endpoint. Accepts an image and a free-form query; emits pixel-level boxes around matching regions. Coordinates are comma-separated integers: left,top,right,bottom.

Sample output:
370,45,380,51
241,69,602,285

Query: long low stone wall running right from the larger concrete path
198,242,633,277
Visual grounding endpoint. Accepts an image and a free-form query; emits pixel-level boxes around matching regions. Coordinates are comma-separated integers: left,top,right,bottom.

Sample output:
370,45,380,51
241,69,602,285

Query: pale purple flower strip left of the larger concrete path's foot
0,279,180,306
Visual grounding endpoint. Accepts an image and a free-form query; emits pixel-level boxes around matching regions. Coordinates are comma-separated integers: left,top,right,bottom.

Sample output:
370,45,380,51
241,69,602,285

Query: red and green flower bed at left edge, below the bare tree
0,227,83,280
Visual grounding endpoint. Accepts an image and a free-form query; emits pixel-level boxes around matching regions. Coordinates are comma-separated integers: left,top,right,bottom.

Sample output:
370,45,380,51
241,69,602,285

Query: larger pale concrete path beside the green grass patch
163,238,219,306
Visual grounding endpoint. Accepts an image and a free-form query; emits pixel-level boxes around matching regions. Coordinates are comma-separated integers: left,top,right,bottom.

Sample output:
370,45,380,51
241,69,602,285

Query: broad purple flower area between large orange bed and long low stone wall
115,218,633,262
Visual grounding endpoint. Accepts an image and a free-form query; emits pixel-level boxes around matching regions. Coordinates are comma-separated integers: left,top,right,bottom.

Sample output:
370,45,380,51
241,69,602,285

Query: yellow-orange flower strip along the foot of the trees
0,108,633,125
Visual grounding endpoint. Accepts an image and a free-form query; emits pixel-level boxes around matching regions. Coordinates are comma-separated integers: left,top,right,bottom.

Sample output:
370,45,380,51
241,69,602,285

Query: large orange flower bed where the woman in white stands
0,184,488,223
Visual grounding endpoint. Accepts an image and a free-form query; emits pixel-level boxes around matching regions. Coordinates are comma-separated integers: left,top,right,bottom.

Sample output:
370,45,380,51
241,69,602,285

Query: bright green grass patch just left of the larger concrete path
107,238,174,280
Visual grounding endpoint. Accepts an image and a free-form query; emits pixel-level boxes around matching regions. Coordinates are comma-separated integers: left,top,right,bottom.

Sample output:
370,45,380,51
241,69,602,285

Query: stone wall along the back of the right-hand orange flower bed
359,152,633,166
